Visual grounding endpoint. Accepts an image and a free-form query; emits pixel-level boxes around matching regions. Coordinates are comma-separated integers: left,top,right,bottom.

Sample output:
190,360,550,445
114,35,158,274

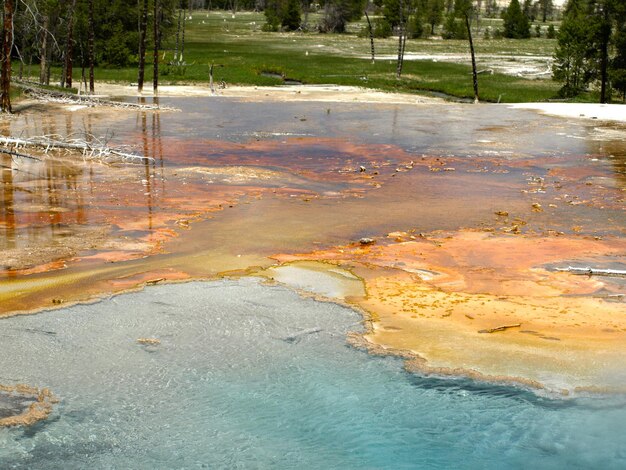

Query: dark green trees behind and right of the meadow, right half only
263,0,626,102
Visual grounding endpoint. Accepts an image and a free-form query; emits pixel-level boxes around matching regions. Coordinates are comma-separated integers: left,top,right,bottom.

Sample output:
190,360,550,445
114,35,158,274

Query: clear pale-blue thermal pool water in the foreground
0,279,626,469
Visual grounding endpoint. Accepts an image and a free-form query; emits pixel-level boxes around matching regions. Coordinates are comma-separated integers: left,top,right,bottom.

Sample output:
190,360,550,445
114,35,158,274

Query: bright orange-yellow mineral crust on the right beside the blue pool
277,231,626,390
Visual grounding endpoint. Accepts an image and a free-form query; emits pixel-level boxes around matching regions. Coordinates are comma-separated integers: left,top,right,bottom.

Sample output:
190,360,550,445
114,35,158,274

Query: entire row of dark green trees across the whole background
0,0,626,111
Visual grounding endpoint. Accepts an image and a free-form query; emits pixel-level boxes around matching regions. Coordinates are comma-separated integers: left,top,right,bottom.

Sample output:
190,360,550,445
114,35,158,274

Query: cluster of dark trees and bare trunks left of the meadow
0,0,180,111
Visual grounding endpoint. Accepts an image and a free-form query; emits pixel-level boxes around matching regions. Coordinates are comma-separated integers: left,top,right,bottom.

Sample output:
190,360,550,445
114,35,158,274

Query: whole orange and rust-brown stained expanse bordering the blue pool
0,102,626,390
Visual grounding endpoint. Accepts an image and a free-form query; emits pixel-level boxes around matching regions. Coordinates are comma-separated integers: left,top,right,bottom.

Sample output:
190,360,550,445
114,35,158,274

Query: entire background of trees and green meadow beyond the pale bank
0,0,626,111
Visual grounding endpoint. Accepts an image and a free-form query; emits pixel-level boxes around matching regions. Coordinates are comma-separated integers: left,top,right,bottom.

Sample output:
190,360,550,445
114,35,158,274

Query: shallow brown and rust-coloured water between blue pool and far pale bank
0,97,626,313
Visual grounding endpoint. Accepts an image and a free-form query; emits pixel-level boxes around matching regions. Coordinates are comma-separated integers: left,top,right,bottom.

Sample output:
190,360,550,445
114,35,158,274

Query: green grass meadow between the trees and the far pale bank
66,11,559,102
